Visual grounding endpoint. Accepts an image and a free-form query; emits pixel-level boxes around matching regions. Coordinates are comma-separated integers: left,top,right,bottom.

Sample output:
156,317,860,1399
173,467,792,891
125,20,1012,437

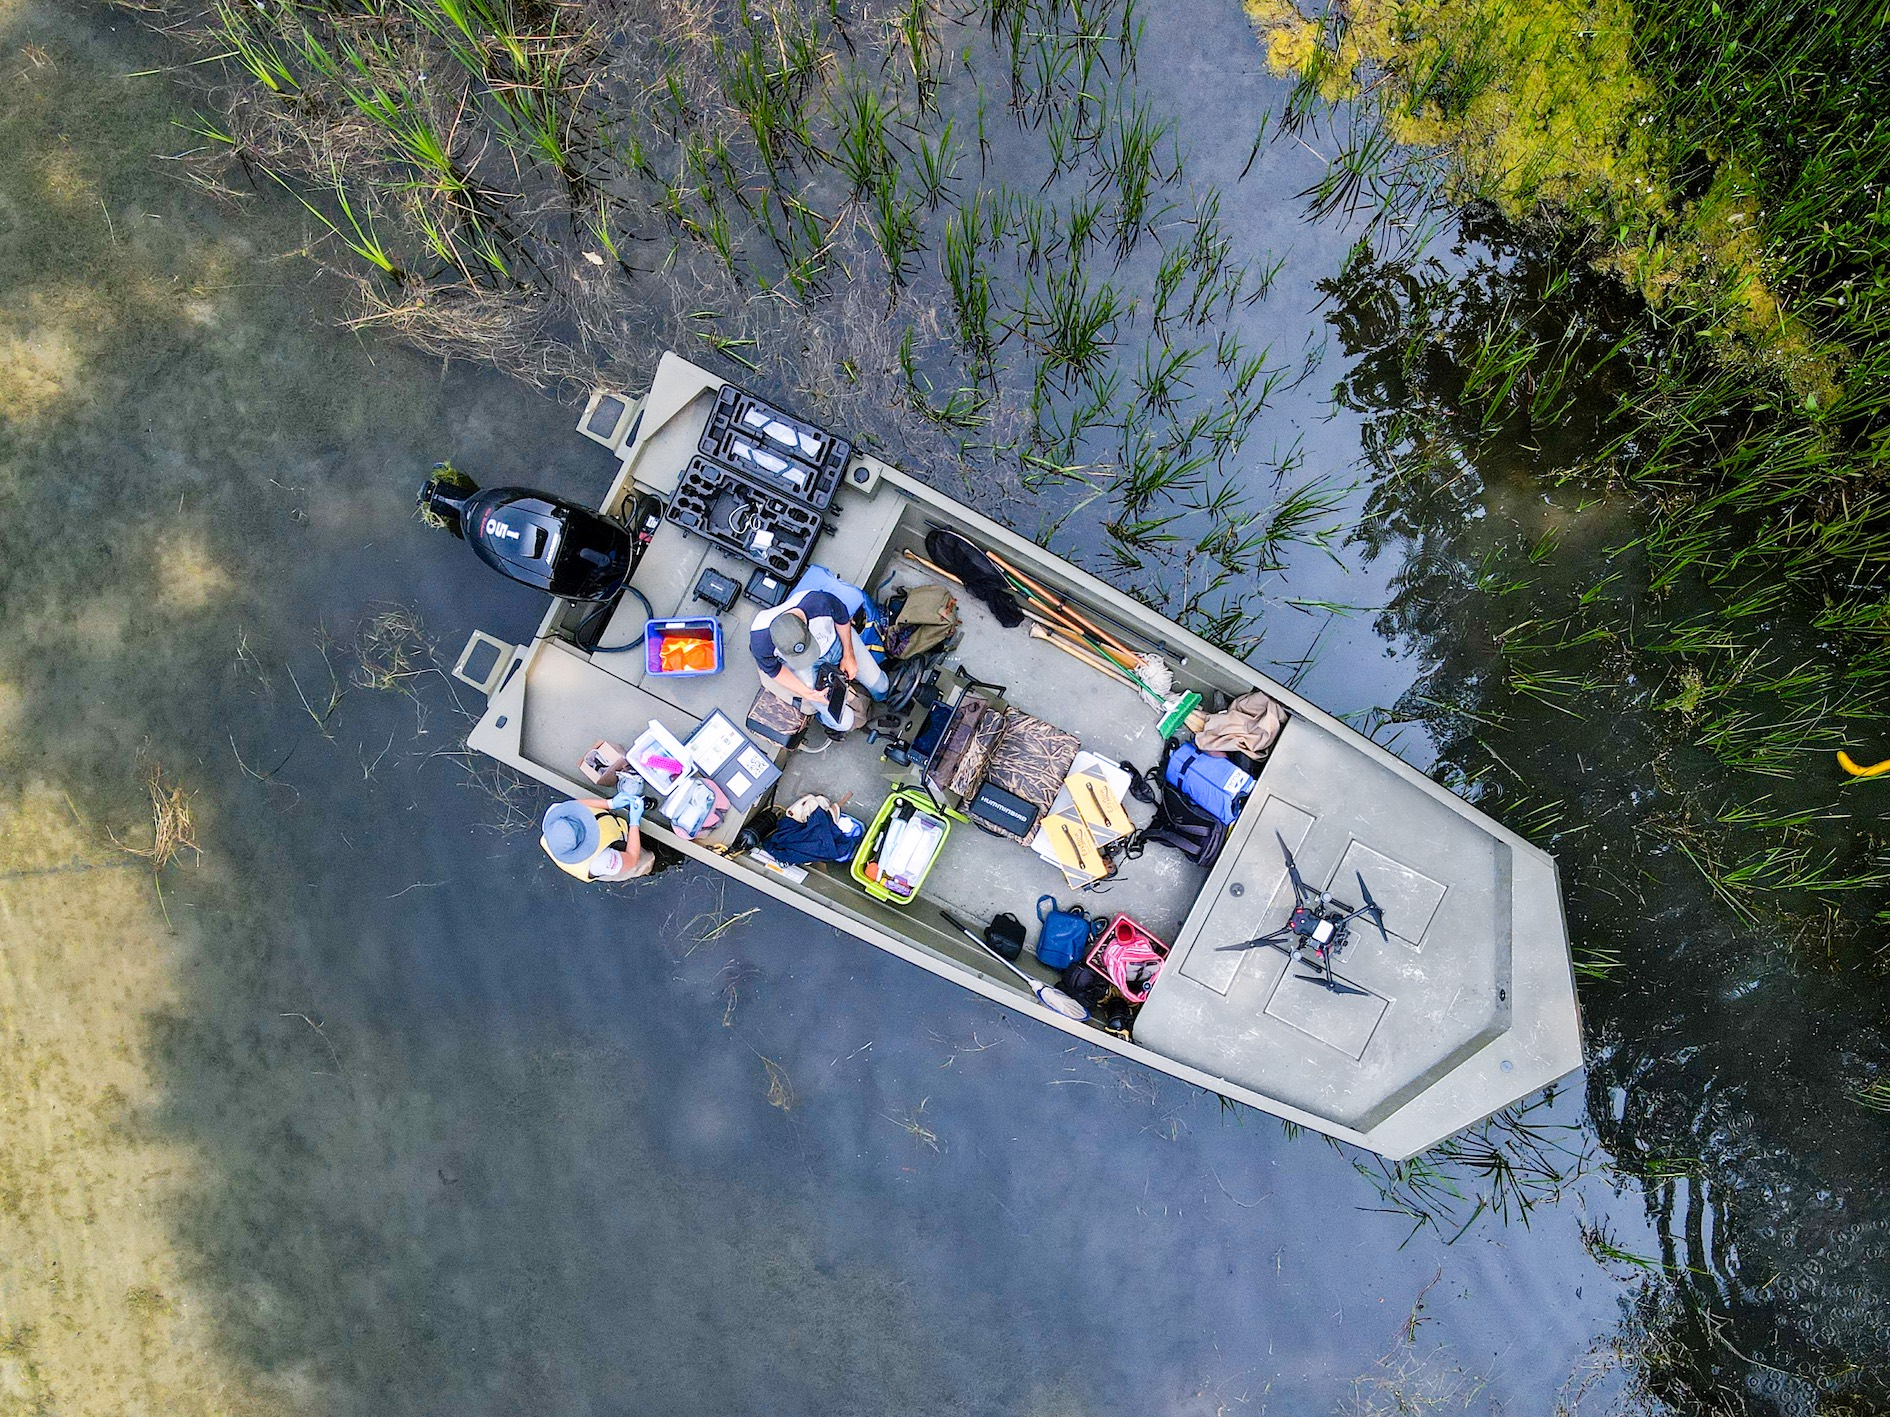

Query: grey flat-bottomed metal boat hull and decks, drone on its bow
454,353,1582,1158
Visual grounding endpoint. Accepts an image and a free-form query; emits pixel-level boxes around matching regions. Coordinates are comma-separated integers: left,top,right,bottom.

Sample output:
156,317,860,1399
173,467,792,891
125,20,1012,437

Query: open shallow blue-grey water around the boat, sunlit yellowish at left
0,4,1890,1413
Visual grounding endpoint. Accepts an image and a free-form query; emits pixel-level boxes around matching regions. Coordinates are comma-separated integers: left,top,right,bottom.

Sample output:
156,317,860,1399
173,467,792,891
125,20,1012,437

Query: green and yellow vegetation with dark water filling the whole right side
1249,0,1890,1411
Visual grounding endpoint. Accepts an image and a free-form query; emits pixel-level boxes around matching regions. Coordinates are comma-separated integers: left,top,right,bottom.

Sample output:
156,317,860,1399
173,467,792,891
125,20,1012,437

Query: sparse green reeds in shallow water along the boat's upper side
155,0,1340,648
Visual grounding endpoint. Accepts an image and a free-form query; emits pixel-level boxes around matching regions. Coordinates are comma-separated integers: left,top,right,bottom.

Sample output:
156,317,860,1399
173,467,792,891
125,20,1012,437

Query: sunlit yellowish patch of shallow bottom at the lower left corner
0,784,310,1417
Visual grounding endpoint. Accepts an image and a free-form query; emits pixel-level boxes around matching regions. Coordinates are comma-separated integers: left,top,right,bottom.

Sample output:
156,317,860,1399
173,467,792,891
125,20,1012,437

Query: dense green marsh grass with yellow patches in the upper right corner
1300,0,1890,853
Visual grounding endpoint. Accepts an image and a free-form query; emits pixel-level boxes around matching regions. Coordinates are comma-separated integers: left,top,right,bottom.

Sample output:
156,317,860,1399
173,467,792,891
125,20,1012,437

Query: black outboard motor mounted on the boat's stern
420,463,662,601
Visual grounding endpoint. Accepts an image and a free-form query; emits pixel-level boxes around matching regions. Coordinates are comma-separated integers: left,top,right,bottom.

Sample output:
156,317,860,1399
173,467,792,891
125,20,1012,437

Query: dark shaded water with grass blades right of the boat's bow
1334,171,1890,1406
